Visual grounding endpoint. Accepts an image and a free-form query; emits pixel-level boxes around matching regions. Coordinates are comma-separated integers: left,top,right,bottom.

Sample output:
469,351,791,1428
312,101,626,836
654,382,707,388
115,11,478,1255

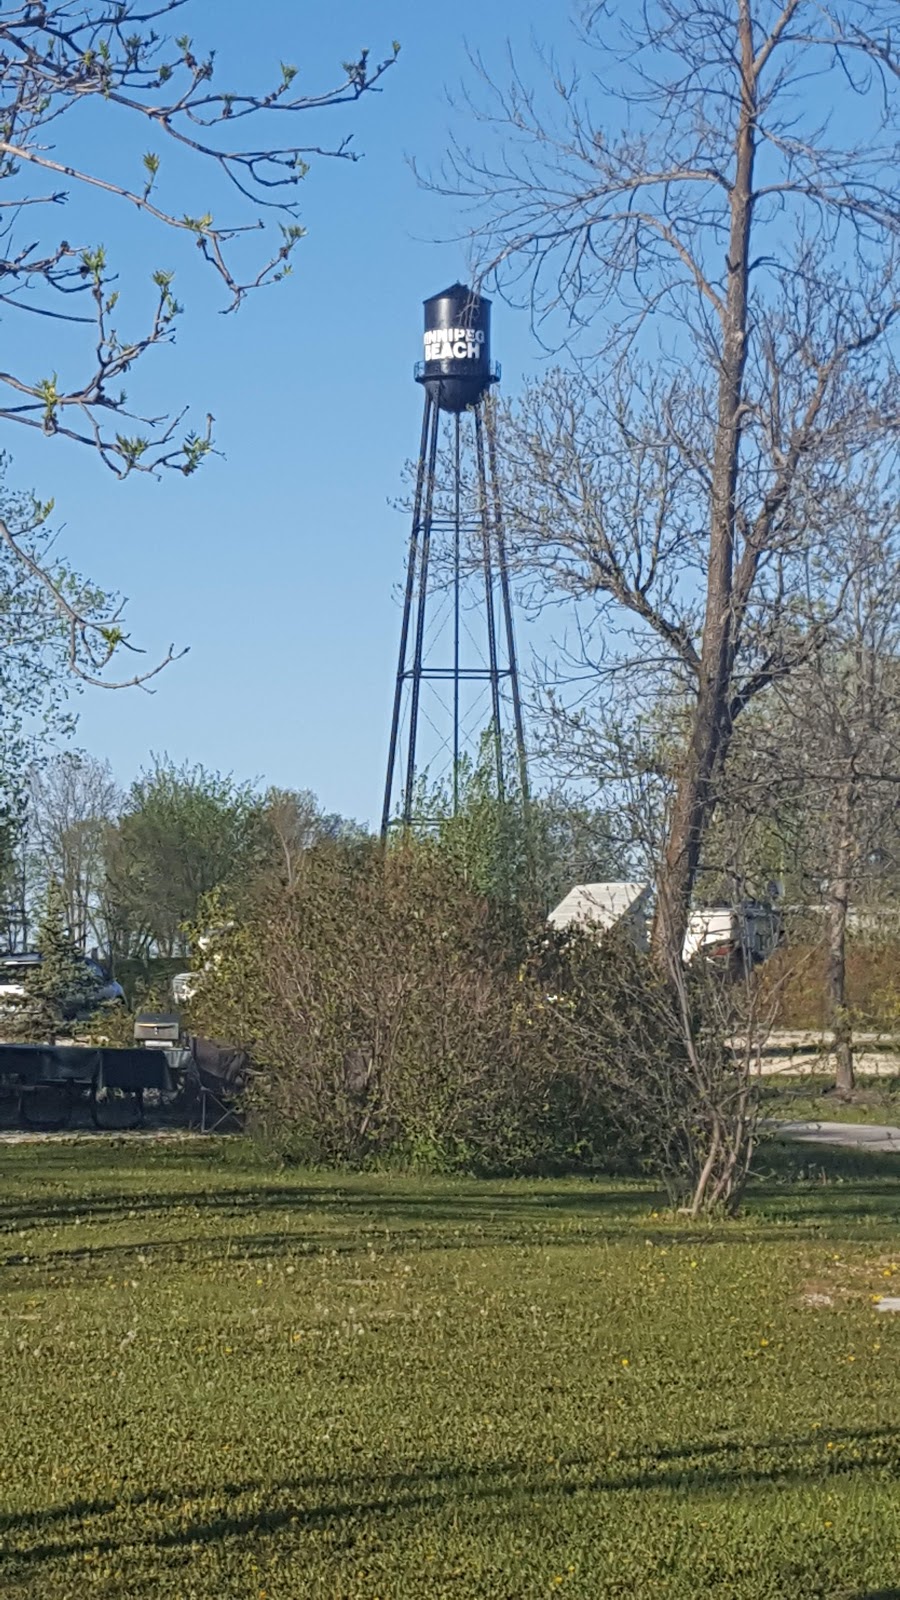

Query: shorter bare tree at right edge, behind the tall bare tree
685,458,900,1094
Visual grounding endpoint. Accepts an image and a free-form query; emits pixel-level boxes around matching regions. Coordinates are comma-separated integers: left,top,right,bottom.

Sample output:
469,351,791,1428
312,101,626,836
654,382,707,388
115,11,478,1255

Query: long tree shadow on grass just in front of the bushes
0,1144,900,1267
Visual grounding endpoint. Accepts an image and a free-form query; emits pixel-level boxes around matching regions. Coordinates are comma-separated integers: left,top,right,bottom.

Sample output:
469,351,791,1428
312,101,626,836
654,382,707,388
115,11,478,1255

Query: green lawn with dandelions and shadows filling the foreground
0,1141,900,1600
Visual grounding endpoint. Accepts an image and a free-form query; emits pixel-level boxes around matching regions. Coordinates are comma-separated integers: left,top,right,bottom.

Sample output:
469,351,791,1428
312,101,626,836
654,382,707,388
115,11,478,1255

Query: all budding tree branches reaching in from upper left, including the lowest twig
0,0,399,688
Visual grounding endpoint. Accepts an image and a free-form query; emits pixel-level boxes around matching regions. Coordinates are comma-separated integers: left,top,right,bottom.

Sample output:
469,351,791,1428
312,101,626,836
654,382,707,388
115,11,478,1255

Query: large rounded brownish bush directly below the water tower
191,842,614,1171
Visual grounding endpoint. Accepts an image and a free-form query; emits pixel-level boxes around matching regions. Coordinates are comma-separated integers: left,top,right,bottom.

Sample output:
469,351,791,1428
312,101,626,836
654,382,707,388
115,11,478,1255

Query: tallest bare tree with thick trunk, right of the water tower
442,0,900,965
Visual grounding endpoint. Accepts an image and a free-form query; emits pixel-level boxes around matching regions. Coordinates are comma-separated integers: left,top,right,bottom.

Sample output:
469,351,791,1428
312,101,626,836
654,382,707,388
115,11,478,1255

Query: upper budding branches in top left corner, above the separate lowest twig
0,0,399,477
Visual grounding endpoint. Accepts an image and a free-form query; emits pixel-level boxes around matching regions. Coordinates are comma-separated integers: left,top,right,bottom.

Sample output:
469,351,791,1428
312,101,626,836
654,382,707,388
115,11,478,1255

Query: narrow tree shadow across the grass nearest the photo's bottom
0,1427,900,1574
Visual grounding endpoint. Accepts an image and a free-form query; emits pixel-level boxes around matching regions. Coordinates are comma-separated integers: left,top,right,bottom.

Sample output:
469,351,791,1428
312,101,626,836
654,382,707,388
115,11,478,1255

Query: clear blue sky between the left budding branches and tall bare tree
3,0,570,819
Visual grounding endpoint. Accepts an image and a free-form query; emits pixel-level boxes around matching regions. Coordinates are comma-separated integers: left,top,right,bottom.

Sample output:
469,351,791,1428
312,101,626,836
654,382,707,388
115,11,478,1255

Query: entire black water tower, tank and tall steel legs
381,283,528,838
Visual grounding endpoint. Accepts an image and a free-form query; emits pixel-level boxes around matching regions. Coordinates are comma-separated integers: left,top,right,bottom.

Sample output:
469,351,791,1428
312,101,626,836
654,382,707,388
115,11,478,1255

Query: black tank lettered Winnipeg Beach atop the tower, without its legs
416,283,500,411
